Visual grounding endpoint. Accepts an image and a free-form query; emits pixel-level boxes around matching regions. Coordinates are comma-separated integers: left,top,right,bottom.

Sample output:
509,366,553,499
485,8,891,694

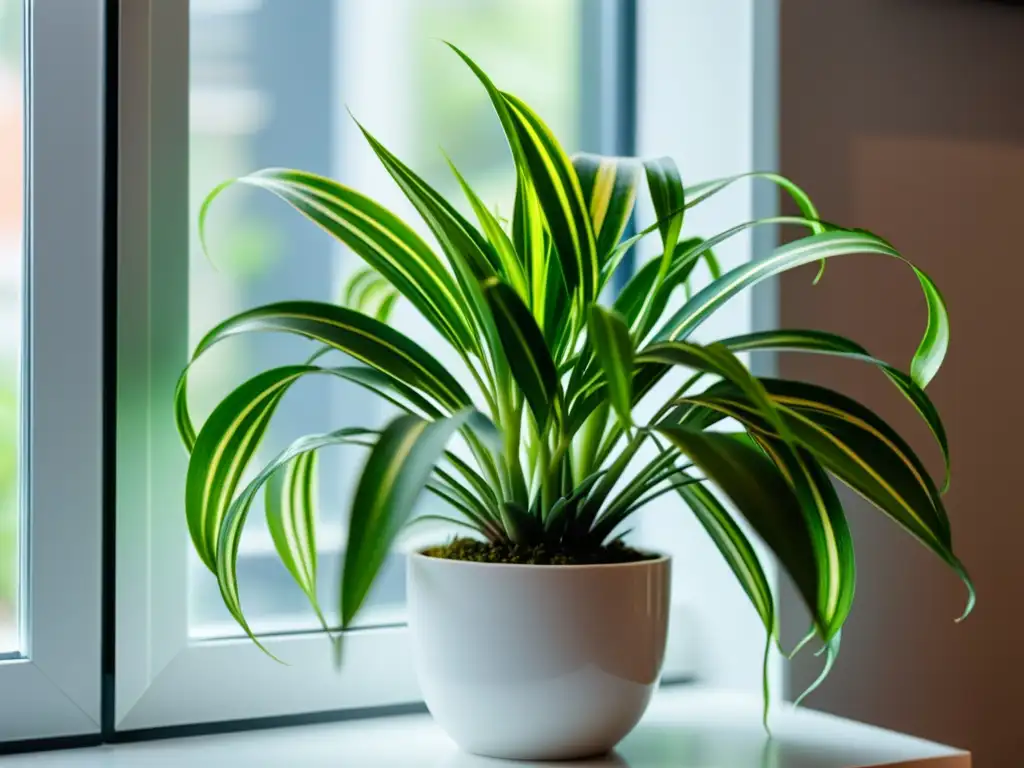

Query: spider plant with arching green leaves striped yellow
175,46,974,708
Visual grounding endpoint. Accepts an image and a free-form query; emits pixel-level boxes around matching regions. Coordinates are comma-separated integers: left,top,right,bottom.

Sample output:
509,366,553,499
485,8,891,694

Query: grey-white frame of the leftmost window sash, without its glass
0,0,104,741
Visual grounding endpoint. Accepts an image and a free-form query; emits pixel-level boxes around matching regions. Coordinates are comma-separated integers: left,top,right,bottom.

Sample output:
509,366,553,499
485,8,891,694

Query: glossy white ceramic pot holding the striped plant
408,554,671,760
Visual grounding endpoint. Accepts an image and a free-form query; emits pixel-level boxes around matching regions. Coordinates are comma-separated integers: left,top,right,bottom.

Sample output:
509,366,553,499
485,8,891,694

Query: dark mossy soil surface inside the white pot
423,539,658,565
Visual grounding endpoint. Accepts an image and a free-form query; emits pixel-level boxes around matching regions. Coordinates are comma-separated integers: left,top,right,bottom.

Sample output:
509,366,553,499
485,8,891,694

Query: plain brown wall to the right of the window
780,0,1024,768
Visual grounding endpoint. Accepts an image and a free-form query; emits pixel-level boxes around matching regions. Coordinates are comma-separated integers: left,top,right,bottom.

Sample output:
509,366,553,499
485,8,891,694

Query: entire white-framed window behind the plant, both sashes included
0,0,770,741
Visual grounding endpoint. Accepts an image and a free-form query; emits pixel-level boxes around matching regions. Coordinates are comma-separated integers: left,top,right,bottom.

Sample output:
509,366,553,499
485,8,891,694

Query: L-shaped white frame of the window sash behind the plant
114,0,419,730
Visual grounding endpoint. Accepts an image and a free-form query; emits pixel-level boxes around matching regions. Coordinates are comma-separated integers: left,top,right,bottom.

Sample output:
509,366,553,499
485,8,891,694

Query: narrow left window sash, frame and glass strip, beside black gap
0,0,103,740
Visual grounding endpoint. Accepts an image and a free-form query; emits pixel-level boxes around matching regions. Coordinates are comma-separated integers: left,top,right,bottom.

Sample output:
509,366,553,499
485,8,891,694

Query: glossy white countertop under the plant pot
0,686,971,768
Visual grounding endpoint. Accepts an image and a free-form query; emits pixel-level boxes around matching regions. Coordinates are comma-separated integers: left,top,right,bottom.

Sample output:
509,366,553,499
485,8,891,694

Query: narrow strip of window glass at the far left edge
0,0,25,655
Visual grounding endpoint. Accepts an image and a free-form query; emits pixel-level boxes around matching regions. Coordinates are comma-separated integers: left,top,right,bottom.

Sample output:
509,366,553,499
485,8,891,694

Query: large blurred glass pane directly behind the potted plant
189,0,584,637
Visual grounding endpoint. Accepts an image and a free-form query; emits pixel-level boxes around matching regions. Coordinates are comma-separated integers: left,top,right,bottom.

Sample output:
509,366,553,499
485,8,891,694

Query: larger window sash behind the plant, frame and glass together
114,0,638,729
